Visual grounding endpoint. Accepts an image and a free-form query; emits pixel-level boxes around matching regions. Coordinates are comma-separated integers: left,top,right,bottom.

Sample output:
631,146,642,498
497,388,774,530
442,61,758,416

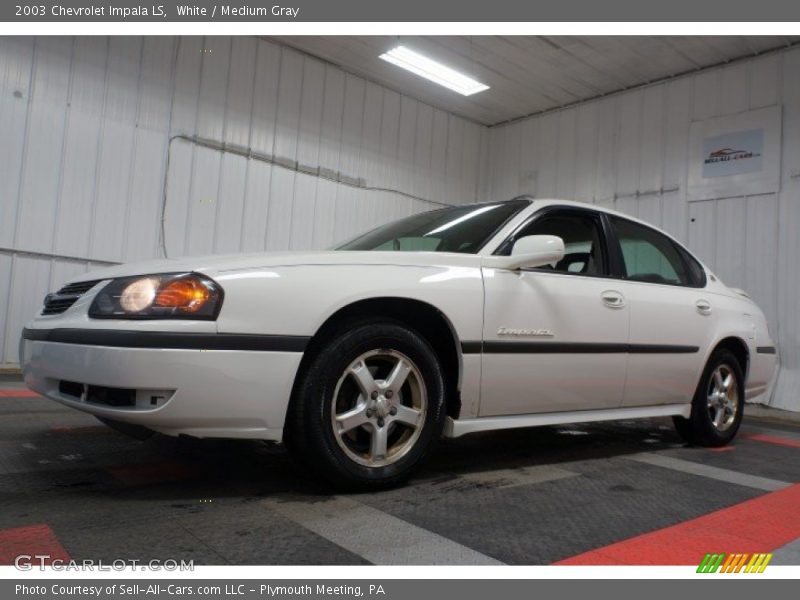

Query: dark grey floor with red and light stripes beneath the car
0,377,800,565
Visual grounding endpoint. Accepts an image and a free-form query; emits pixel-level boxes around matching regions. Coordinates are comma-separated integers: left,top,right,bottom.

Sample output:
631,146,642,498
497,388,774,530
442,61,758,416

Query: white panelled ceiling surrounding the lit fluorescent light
271,36,800,125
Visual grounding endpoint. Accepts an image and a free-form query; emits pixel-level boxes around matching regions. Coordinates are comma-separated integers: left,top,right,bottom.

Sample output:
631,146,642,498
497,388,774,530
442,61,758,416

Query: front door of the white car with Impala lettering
480,207,629,416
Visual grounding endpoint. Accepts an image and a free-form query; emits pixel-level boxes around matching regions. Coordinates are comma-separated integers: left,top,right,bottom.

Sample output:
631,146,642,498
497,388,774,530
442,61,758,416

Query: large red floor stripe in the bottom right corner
556,484,800,565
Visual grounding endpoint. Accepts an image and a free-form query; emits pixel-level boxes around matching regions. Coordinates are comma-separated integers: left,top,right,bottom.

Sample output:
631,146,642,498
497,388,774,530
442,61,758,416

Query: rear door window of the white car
611,217,697,286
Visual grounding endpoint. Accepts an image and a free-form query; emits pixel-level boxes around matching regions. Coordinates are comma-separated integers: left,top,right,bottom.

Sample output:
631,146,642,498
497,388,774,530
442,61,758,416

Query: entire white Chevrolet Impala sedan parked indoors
21,197,776,487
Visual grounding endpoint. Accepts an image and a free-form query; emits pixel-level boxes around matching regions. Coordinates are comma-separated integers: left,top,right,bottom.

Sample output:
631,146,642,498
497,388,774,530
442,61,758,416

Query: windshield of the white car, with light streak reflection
336,200,530,254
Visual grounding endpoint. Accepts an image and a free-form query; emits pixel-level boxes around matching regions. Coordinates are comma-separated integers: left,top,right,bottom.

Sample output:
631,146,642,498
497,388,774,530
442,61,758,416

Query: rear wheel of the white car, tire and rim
673,348,744,446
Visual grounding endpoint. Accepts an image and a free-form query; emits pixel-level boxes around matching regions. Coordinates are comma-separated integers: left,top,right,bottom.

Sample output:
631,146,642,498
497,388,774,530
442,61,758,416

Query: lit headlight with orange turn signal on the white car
89,273,222,320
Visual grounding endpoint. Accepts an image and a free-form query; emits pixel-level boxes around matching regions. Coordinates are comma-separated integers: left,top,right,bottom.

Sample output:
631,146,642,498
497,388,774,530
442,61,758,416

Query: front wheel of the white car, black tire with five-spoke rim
284,320,445,490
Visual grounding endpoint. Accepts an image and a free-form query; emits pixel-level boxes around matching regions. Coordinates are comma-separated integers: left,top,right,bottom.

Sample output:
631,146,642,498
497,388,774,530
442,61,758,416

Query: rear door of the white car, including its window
608,216,716,406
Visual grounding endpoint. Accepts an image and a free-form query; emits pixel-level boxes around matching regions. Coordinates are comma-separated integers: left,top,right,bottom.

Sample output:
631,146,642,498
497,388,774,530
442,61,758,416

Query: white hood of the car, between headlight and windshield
71,250,481,282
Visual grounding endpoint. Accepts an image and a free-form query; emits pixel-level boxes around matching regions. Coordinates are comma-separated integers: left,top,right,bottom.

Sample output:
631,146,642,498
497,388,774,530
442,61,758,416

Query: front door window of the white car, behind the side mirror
507,212,606,275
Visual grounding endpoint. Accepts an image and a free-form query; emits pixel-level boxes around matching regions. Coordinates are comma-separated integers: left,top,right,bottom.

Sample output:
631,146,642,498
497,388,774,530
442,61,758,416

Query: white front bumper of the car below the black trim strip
20,339,303,441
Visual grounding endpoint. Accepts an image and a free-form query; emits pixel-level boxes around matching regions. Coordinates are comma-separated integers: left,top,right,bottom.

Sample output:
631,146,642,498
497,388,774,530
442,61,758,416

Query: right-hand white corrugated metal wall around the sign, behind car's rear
481,49,800,410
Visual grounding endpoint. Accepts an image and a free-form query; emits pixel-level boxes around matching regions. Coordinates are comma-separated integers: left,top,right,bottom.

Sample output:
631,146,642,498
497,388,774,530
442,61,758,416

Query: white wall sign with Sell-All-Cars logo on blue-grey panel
689,106,781,200
